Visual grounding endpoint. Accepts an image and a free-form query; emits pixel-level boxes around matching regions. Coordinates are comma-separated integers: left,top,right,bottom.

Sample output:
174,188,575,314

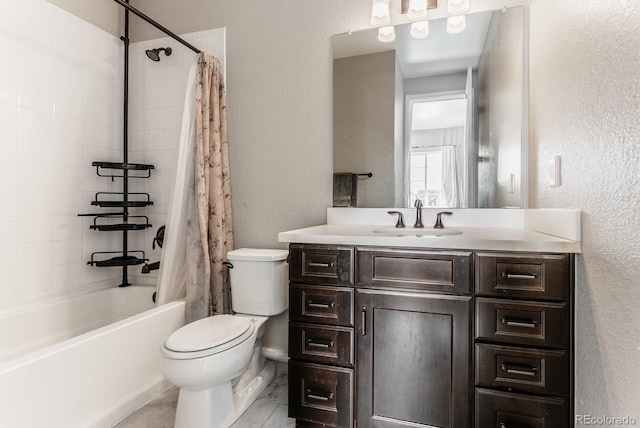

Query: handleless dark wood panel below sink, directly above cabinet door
357,248,471,293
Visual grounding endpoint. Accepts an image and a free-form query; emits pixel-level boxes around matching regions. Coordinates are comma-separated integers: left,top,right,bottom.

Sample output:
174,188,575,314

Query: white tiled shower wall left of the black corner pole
0,0,123,307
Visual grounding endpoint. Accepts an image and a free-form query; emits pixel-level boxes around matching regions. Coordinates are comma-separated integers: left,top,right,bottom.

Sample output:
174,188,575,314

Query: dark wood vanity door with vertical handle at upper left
356,290,472,428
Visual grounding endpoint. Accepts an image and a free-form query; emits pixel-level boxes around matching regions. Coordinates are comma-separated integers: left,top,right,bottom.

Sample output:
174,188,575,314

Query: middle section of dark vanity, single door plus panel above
355,248,473,428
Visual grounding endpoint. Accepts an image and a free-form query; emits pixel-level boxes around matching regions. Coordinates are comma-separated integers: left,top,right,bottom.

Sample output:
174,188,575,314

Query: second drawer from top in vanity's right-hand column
476,298,569,348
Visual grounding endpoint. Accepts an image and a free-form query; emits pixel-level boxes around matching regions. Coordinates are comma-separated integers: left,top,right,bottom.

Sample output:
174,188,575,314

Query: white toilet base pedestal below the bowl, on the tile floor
174,361,276,428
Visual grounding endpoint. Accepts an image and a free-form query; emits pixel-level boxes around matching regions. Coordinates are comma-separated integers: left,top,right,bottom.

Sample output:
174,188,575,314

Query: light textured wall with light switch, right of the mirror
531,0,640,420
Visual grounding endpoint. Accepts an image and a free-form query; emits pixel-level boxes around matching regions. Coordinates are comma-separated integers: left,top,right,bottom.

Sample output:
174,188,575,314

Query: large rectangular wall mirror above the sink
333,7,529,208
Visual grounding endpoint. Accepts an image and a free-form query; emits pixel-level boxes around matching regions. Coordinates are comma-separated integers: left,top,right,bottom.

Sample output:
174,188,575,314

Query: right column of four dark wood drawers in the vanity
475,252,573,428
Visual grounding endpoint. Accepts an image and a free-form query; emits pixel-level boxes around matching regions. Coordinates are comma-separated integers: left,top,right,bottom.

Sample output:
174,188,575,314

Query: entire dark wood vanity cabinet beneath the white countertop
289,243,574,428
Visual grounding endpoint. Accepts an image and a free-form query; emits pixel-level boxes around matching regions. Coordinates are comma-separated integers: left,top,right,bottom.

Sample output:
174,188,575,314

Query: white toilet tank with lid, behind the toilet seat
227,248,289,316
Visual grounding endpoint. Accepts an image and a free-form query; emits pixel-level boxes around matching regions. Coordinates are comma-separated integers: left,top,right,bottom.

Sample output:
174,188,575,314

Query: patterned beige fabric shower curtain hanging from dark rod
186,52,233,323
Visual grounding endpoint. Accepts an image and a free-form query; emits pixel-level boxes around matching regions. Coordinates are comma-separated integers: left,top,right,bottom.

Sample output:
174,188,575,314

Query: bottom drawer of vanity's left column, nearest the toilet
289,361,353,428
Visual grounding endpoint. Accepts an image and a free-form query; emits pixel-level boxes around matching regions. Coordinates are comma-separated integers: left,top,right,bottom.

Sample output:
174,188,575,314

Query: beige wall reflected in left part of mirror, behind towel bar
333,51,396,207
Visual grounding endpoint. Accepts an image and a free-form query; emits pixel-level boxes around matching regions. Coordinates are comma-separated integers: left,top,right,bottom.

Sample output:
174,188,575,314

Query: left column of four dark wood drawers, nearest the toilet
289,244,355,428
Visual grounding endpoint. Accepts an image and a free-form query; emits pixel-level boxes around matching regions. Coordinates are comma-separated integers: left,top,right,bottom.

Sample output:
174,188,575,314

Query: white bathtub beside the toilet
0,285,184,428
